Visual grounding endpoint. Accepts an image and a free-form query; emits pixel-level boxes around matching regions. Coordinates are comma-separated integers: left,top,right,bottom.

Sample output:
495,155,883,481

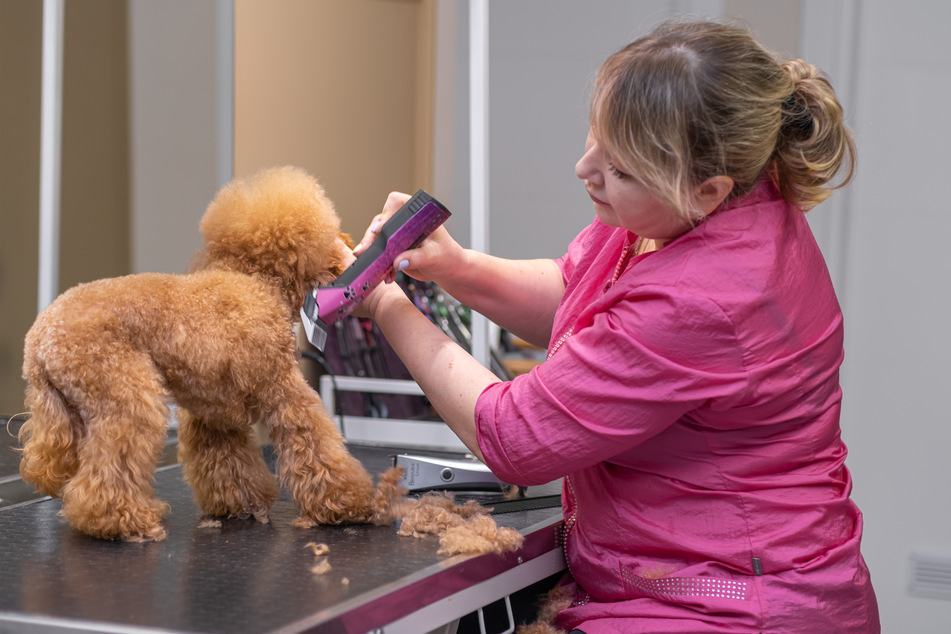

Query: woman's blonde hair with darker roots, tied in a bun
590,21,855,221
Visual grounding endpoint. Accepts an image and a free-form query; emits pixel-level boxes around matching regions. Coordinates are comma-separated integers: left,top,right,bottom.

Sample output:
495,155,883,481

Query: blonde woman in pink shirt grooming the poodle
358,21,880,634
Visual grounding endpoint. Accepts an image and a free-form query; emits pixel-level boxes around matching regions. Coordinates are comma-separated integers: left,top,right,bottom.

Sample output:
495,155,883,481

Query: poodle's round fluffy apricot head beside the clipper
192,167,349,310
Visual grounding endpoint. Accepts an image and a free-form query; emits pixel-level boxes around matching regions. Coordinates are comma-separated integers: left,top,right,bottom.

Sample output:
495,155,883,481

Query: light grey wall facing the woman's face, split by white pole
434,0,688,258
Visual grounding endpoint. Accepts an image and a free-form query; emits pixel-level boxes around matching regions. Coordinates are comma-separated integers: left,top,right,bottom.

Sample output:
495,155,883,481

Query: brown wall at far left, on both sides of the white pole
0,0,129,414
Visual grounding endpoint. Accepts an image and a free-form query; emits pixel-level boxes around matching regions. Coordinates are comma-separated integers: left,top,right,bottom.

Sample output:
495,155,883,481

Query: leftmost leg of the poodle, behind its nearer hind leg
18,376,85,497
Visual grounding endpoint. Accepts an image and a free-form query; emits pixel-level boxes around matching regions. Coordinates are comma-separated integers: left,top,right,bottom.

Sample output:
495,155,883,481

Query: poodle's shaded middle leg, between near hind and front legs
178,408,280,522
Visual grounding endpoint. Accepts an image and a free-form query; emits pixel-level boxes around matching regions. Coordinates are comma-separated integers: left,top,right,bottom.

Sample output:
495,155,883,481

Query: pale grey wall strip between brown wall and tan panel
128,0,233,273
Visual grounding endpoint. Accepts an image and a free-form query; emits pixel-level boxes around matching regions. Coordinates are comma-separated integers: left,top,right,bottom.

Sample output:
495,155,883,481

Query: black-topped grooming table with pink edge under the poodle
0,445,565,634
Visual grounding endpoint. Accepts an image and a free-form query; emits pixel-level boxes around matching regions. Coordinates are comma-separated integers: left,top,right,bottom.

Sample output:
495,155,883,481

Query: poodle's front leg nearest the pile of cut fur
265,373,373,527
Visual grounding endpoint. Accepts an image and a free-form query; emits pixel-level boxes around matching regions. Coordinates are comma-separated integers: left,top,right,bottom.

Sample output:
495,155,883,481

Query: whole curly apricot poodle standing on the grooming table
20,167,374,541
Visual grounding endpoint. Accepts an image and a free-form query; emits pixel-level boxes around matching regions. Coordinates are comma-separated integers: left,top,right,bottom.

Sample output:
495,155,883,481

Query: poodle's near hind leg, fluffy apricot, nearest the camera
55,348,169,541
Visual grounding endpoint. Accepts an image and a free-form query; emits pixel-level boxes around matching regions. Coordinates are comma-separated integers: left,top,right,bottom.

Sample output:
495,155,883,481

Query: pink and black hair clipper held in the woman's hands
301,190,451,351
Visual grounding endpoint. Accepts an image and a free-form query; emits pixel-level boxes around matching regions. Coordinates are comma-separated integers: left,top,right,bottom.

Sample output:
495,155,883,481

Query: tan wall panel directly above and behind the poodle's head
235,0,434,237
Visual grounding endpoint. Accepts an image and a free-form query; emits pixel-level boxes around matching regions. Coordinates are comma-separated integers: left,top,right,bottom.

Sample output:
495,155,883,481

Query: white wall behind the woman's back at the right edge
804,0,951,634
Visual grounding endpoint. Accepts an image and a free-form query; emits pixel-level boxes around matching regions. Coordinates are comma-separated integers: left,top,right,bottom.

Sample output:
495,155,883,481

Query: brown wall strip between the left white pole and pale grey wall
59,0,130,290
